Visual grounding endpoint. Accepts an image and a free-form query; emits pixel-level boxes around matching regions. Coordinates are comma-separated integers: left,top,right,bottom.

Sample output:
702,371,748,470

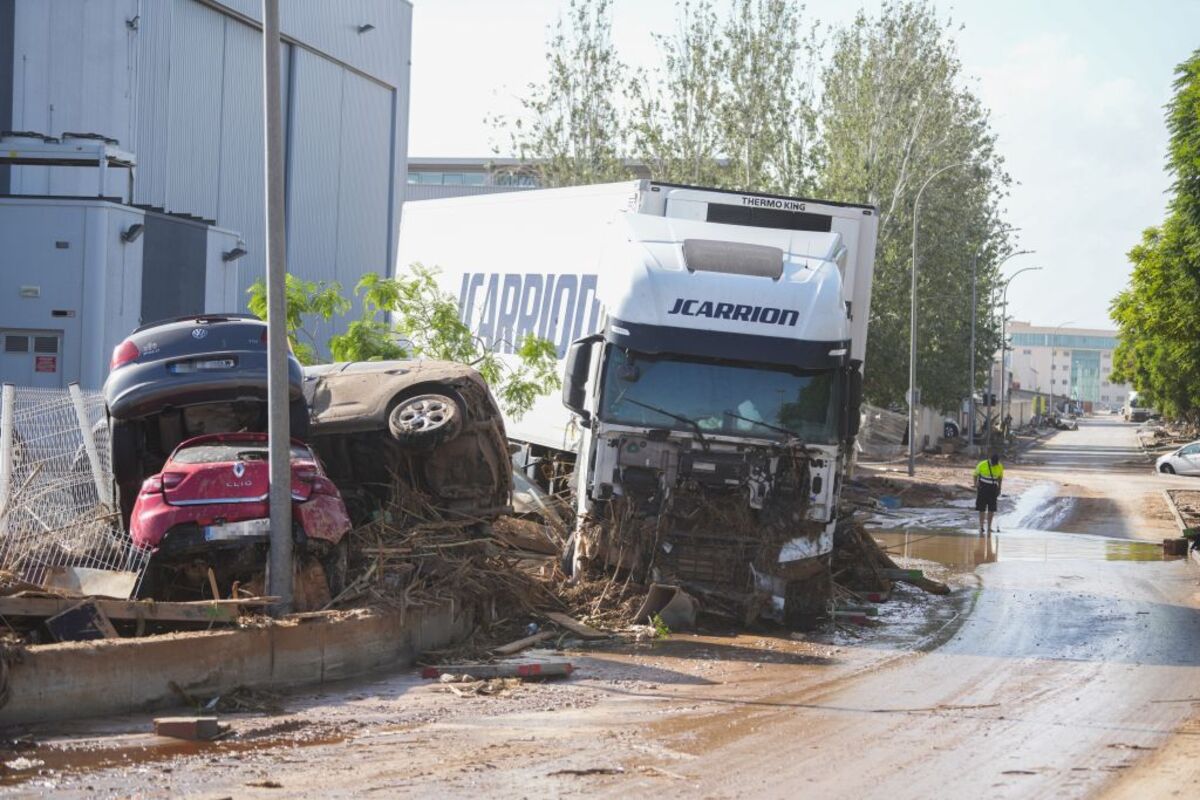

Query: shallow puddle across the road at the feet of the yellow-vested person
871,528,1163,570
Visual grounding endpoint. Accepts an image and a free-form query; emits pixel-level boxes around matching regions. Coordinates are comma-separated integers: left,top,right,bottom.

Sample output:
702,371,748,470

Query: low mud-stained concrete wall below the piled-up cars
0,604,473,726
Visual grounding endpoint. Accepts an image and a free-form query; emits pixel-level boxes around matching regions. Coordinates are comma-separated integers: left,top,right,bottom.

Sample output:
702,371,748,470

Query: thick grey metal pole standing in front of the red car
263,0,293,614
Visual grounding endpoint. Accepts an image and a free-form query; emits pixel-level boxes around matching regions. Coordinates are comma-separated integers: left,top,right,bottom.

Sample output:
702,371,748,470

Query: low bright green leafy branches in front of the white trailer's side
248,264,562,417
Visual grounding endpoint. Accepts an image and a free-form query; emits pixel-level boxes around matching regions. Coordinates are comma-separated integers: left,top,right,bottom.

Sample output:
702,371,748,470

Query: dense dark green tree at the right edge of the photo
1110,50,1200,423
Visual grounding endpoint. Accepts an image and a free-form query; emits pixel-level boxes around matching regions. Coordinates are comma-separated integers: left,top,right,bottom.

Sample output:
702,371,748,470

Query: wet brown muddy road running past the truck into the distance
0,419,1200,799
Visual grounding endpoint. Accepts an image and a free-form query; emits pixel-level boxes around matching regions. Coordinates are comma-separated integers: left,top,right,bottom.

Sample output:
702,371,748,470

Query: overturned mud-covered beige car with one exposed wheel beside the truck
304,361,512,524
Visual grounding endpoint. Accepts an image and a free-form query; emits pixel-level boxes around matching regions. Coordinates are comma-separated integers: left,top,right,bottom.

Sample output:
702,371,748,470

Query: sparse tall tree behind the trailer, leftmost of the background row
492,0,630,186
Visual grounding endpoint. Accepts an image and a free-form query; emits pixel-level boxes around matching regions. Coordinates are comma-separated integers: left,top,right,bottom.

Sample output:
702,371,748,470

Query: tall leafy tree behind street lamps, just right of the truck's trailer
818,2,1010,409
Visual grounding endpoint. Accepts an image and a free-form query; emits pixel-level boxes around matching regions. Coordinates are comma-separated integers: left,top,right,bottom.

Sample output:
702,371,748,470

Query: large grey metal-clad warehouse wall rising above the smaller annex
0,0,412,331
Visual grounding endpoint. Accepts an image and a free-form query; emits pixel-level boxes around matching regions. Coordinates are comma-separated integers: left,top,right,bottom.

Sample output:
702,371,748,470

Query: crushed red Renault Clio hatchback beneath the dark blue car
130,433,350,600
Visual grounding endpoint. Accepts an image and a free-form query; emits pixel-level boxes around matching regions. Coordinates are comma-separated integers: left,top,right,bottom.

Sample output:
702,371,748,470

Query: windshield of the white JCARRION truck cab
600,348,839,444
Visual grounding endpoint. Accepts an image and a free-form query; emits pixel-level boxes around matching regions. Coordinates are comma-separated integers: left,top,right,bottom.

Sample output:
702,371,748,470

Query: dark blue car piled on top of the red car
103,314,308,523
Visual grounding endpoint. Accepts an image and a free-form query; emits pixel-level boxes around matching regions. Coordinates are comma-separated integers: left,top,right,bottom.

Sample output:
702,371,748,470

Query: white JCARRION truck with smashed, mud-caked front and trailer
397,180,877,621
